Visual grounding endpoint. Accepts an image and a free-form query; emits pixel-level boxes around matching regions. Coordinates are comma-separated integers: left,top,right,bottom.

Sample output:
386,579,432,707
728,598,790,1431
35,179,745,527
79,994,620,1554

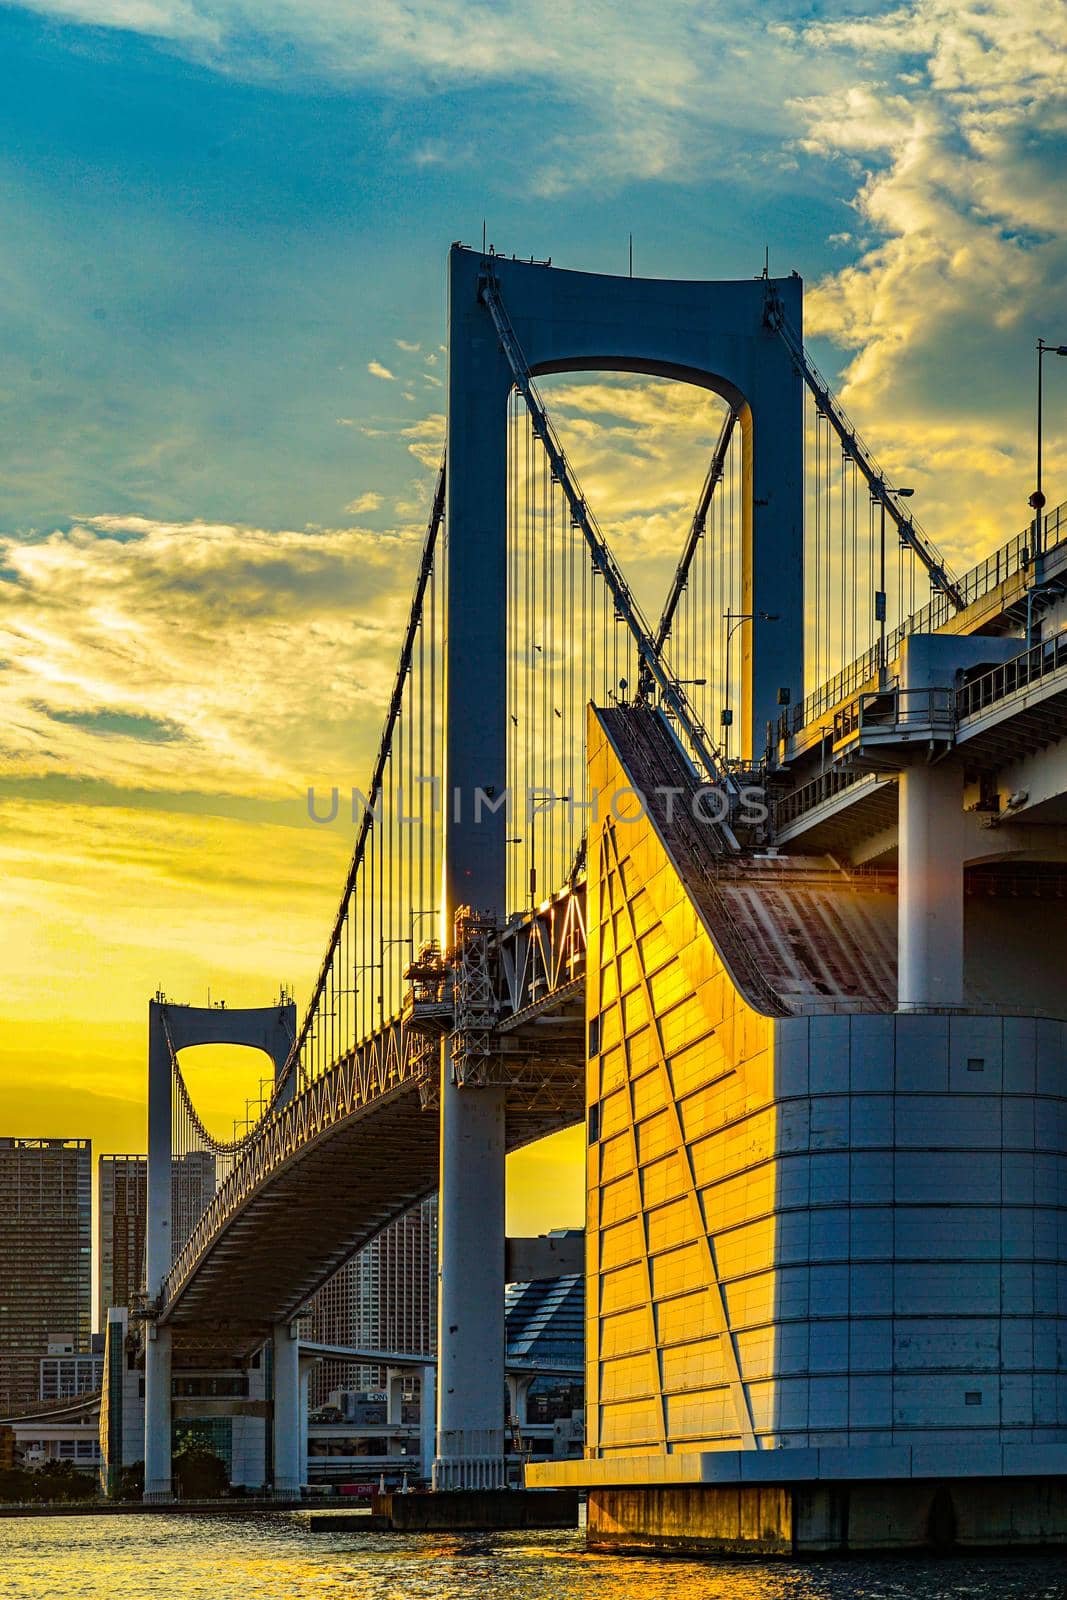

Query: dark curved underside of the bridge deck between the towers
166,1075,584,1366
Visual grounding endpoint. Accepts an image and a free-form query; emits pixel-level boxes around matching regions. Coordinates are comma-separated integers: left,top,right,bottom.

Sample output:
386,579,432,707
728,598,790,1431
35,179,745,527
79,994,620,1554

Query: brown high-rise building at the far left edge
0,1138,93,1416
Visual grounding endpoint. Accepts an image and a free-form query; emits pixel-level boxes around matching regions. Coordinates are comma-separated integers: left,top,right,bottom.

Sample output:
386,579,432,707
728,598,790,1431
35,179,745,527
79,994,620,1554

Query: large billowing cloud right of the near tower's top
783,0,1067,562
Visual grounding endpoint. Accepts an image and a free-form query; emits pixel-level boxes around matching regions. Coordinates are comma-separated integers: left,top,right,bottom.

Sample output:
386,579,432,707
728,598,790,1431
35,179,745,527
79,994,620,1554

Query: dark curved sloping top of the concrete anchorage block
592,706,897,1016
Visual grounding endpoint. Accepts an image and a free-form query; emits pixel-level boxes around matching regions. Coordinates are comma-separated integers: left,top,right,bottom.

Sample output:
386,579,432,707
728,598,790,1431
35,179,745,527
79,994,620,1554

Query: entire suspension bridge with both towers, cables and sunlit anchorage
112,246,1067,1547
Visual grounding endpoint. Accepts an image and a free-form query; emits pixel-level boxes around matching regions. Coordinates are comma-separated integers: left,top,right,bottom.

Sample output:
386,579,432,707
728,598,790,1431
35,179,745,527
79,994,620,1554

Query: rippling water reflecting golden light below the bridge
0,1517,1067,1600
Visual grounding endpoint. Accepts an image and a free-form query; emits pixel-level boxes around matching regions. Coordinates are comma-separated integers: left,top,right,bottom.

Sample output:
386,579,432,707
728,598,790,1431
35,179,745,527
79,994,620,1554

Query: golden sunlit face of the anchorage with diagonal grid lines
585,714,776,1458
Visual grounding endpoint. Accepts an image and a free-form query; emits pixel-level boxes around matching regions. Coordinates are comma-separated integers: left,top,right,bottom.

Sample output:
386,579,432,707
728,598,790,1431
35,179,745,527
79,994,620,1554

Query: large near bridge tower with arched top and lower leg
434,245,803,1488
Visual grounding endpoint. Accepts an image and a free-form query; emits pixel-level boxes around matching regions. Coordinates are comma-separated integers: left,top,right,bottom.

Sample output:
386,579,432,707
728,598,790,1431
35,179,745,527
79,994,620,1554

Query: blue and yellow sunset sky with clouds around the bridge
0,0,1067,1230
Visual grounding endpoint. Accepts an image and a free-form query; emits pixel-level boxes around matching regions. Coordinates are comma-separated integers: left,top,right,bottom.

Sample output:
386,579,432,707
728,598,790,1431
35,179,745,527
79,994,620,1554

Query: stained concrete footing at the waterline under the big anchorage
587,1478,1067,1557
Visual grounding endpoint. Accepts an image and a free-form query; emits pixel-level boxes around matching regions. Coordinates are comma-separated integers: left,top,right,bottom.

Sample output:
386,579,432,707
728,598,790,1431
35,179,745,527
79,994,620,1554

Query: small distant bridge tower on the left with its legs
144,997,299,1501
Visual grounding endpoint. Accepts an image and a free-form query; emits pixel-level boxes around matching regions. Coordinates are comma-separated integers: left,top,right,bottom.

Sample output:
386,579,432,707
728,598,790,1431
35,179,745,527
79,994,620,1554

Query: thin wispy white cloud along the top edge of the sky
0,0,851,195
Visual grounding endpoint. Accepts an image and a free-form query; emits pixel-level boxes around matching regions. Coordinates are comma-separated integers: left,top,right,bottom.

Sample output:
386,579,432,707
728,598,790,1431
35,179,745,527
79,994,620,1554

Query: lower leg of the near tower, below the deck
434,1043,506,1490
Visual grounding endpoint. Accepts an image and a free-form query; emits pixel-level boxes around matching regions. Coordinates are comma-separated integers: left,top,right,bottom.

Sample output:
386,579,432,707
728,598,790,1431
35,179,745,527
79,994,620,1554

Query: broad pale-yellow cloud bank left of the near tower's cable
0,509,424,795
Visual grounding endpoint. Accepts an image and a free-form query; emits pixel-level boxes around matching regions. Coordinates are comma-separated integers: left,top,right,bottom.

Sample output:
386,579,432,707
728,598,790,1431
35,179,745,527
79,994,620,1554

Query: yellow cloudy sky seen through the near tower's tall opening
506,366,747,907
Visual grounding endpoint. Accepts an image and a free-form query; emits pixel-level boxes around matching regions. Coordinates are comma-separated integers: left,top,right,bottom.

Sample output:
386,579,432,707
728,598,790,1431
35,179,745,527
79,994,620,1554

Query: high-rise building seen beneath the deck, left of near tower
309,1197,437,1403
